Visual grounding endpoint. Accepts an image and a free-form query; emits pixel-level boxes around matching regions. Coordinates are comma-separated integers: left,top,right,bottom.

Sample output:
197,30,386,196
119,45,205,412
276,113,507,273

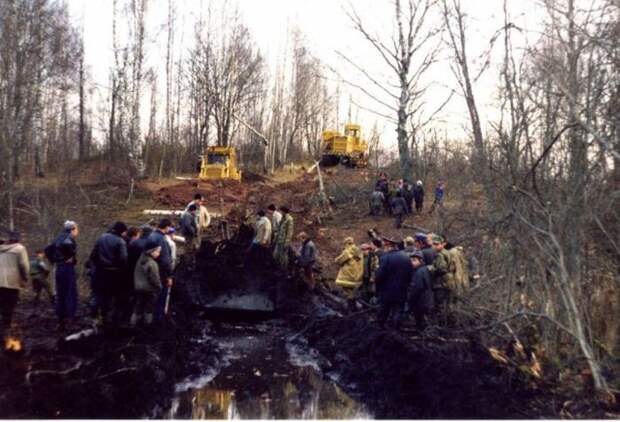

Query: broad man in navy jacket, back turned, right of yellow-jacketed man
375,238,413,328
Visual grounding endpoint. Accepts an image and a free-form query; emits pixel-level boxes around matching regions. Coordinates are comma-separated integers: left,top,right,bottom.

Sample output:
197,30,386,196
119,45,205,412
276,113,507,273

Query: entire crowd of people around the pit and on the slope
0,182,478,346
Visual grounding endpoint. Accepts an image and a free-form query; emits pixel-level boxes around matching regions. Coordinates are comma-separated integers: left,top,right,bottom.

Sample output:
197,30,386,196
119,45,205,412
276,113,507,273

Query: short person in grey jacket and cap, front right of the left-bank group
129,241,162,327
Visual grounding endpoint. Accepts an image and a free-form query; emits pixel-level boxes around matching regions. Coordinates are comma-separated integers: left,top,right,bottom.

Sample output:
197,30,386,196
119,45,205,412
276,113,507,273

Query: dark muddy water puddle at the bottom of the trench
167,327,372,419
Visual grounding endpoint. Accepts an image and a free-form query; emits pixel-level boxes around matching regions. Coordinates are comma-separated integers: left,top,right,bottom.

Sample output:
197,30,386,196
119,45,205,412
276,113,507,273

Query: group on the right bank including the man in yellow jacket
335,233,479,329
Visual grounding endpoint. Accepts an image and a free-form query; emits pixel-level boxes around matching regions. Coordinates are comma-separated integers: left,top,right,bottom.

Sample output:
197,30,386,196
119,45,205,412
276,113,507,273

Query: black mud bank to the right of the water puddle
298,316,532,419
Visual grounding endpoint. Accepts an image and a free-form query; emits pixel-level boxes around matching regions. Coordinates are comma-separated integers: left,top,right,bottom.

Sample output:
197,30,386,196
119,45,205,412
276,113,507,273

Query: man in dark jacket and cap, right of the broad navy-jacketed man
408,251,433,330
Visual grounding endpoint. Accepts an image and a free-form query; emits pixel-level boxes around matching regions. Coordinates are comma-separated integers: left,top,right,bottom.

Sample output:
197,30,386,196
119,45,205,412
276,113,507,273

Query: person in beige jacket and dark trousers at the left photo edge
0,231,30,346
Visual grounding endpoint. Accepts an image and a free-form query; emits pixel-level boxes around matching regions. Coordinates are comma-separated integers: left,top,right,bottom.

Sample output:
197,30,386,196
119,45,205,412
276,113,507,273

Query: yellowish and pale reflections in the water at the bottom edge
170,367,370,419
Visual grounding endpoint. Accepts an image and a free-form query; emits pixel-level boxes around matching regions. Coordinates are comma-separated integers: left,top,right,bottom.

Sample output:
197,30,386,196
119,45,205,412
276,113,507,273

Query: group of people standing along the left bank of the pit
0,194,211,338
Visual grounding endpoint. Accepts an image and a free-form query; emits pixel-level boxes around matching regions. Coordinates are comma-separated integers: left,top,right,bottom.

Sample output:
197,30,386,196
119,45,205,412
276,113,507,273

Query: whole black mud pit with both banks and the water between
0,224,553,418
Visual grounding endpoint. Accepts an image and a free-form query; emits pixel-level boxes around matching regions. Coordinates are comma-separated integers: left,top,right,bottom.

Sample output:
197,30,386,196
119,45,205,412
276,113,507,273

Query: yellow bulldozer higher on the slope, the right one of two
321,124,368,167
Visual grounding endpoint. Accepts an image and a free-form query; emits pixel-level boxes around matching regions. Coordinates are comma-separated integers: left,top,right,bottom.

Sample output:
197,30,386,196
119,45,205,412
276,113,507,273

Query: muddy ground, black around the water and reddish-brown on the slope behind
0,170,610,418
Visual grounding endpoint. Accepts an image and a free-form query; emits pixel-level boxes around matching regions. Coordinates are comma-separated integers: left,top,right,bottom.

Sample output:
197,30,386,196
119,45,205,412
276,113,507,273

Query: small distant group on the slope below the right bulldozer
370,173,445,229
